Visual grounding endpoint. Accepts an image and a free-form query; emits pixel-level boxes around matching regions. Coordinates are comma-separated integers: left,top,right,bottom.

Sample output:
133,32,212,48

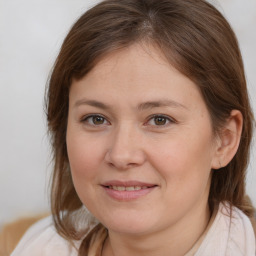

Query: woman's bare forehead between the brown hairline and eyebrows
70,44,206,112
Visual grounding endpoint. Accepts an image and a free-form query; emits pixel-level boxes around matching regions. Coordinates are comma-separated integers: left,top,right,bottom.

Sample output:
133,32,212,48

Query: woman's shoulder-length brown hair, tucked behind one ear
47,0,253,255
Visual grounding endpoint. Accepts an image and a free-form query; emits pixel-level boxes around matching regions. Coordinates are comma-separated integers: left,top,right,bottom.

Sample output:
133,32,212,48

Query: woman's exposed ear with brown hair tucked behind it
212,110,243,169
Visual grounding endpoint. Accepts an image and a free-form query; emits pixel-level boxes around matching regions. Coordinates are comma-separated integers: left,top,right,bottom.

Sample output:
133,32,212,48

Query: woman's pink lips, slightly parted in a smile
101,180,157,201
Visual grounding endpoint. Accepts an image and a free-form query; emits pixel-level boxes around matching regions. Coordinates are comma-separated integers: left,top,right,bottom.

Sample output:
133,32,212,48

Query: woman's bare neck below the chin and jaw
102,201,210,256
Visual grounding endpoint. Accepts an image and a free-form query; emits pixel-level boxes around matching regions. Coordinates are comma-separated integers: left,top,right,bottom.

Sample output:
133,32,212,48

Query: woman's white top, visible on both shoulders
11,203,256,256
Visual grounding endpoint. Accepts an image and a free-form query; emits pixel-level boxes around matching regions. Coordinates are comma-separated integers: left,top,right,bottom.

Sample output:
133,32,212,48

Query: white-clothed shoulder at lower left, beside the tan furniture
11,216,80,256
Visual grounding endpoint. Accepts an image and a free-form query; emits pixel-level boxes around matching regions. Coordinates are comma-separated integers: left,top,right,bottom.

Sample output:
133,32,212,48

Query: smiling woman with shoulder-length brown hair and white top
12,0,255,256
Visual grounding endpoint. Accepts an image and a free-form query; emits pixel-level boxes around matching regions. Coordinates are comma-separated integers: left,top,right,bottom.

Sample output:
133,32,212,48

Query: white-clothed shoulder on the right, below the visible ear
196,203,255,256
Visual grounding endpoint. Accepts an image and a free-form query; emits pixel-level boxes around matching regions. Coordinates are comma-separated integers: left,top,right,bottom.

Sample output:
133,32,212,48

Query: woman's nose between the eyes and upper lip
105,126,146,170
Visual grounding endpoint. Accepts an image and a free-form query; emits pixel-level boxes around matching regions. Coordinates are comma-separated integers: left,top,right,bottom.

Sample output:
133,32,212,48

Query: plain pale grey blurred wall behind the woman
0,0,256,227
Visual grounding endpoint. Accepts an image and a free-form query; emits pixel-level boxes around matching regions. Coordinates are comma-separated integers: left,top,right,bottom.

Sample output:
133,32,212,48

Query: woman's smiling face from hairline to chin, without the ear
67,45,219,234
